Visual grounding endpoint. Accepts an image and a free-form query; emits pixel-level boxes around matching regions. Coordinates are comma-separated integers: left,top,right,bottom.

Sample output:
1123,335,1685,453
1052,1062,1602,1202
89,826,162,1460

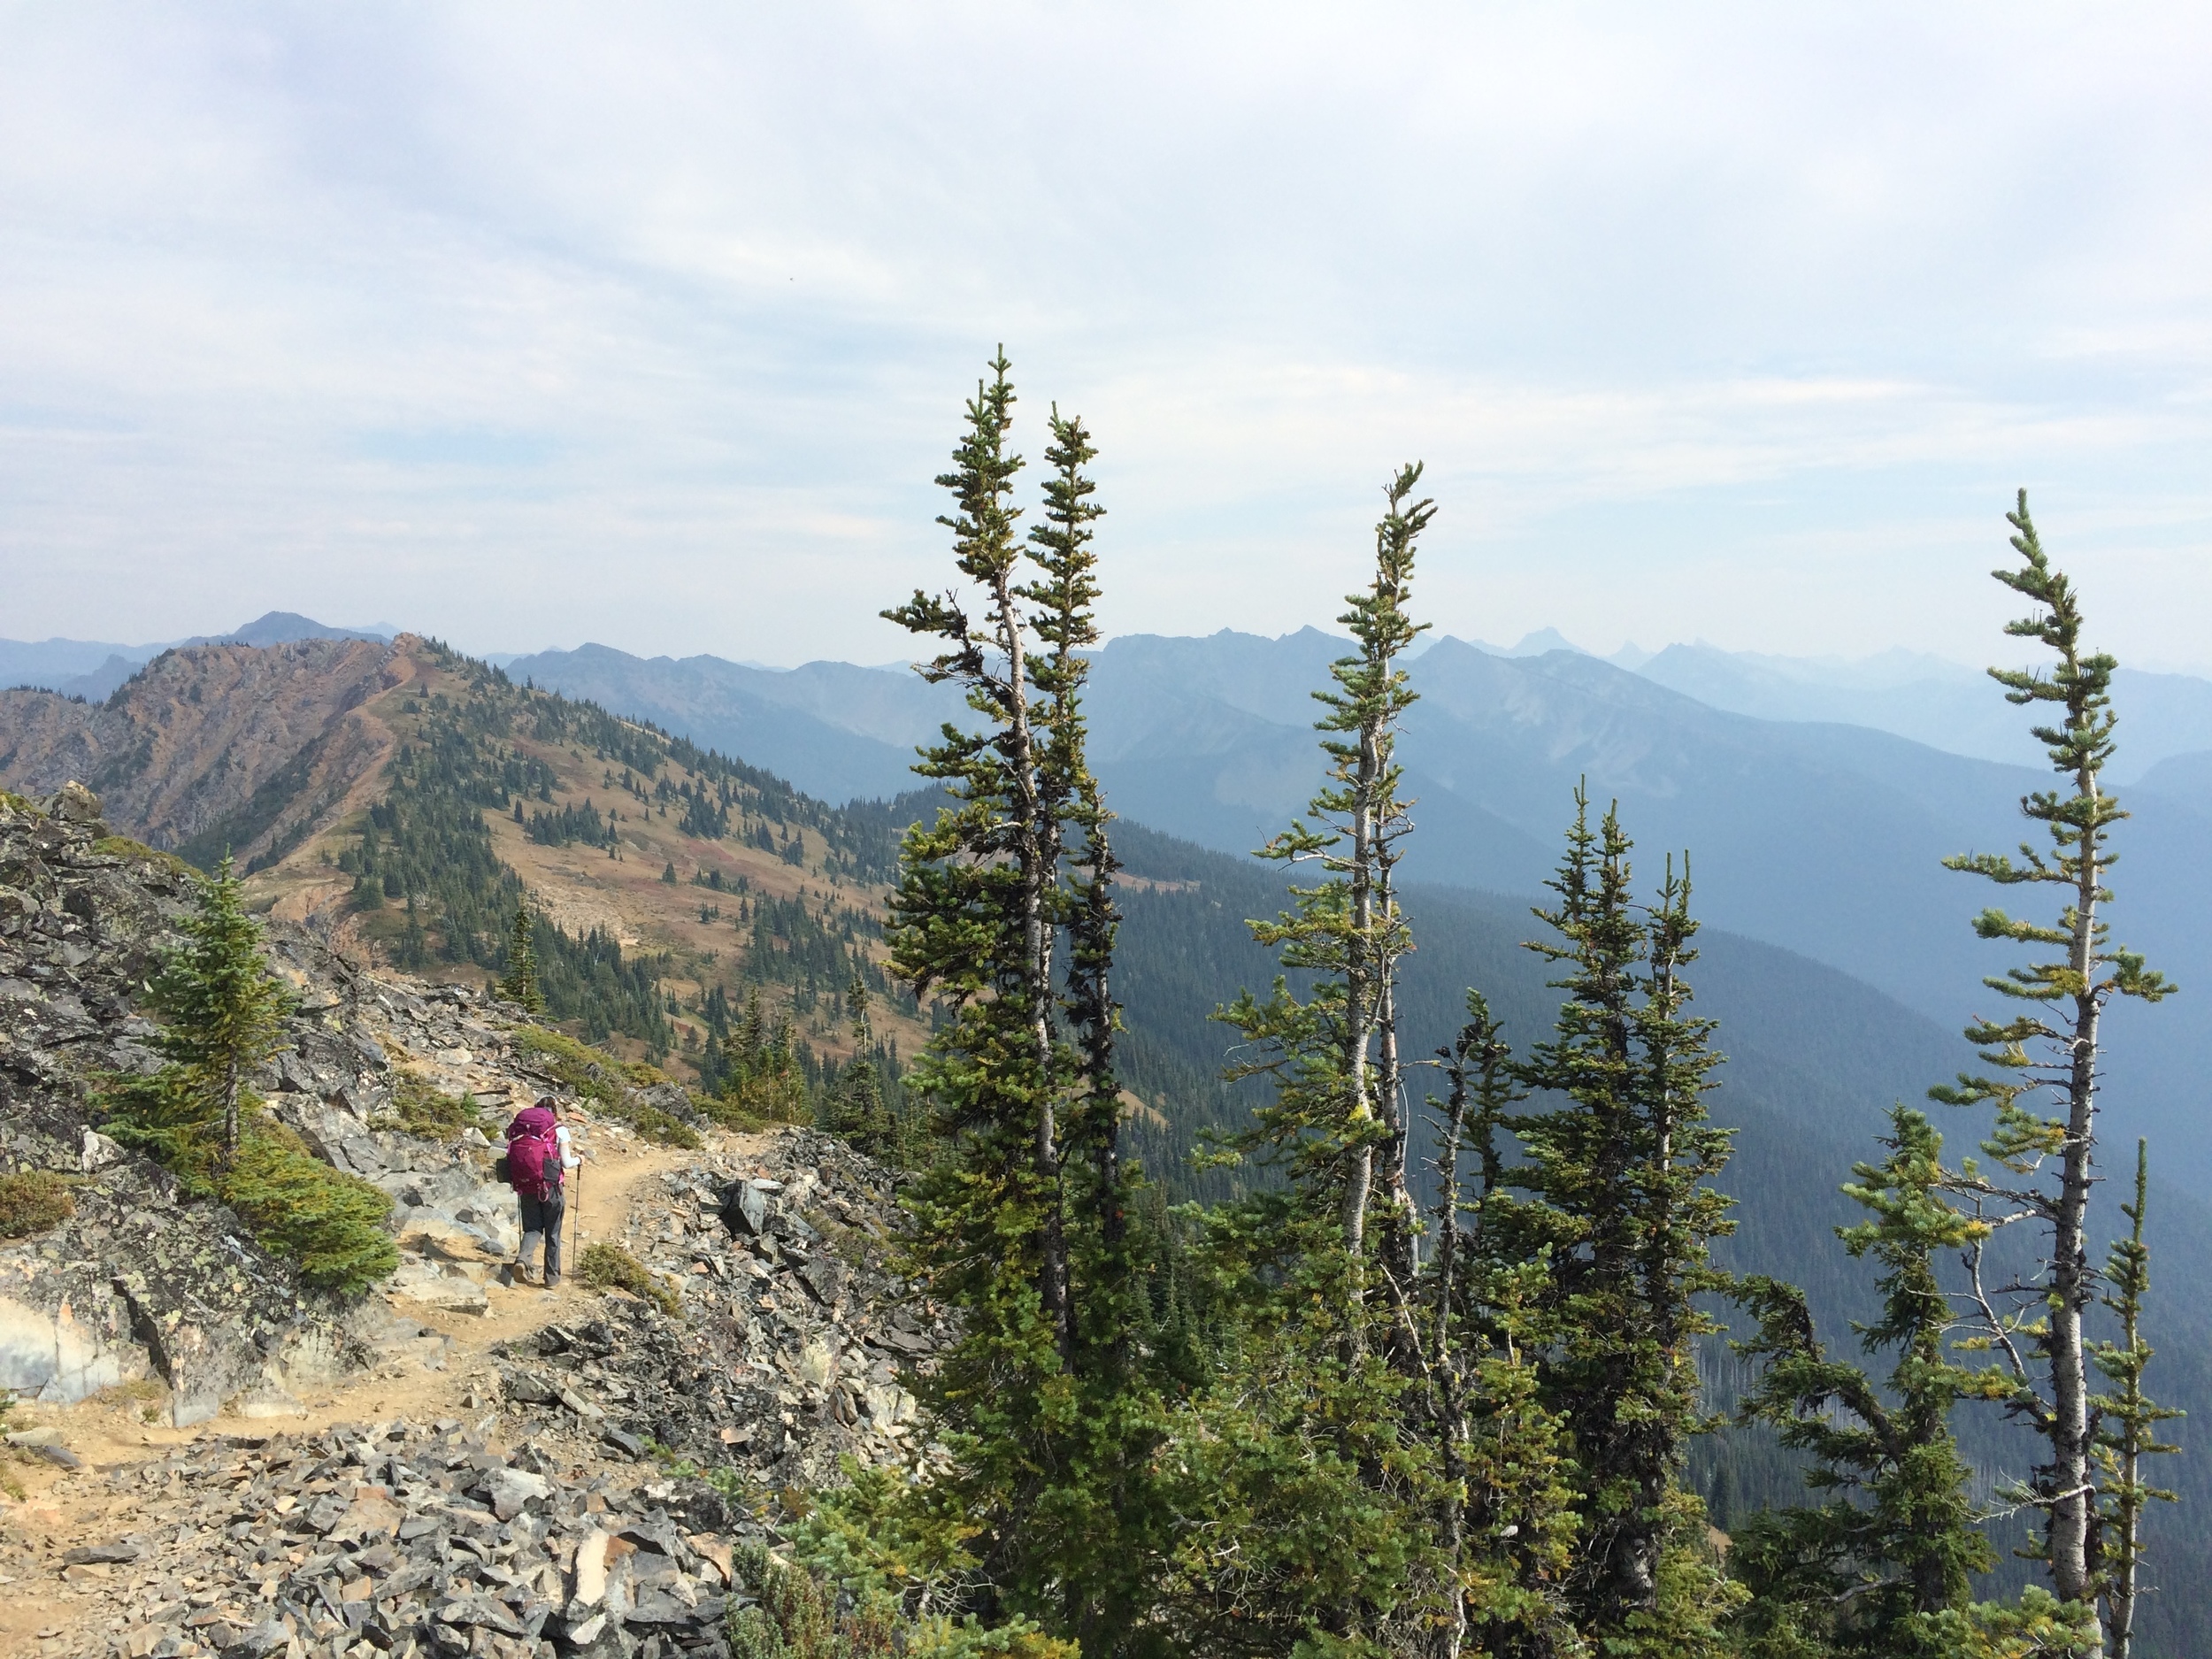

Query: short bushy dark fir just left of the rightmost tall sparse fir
1730,1106,2002,1659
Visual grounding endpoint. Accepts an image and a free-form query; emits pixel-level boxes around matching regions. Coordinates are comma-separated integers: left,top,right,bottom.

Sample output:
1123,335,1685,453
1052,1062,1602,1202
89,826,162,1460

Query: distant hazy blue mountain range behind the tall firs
509,628,2212,1179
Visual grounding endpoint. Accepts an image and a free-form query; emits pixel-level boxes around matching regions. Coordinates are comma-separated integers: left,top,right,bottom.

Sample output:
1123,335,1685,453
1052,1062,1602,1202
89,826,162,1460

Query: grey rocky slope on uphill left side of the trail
0,786,863,1427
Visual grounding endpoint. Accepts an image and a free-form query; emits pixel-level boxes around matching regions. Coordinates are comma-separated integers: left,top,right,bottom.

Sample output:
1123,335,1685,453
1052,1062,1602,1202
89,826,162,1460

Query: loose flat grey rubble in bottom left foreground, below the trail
45,1420,757,1659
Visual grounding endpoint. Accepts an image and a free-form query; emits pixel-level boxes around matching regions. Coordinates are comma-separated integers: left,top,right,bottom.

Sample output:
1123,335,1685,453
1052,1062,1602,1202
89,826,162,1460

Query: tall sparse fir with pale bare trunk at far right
1929,491,2172,1637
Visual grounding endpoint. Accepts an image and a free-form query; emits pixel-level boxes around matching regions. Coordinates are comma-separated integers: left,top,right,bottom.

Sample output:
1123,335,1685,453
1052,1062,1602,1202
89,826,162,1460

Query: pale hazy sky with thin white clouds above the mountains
0,0,2212,666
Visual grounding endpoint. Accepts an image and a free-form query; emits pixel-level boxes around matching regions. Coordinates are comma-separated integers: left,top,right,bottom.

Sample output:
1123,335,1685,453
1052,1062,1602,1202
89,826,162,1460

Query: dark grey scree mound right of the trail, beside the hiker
500,1131,949,1486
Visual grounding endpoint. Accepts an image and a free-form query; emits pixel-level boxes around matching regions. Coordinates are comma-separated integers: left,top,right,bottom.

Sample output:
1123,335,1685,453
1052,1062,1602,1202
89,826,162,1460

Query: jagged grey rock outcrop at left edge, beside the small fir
0,786,380,1423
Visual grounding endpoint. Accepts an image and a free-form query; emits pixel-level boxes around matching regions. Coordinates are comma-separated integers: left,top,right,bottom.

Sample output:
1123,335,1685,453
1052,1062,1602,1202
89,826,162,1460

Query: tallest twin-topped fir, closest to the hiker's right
885,354,1153,1650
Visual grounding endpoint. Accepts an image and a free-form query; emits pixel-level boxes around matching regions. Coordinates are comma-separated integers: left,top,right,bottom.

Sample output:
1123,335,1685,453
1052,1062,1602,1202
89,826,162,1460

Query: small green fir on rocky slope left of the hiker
153,854,292,1168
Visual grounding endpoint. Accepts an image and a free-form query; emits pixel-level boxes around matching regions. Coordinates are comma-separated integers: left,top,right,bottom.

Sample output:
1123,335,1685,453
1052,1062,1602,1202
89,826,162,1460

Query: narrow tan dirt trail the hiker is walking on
0,1133,765,1659
